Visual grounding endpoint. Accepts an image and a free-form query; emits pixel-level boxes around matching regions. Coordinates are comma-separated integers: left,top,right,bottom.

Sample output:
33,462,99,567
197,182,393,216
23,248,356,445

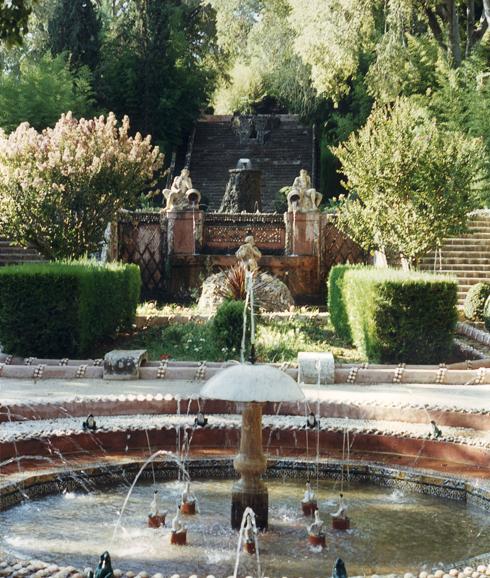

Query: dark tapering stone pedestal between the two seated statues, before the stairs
218,169,262,213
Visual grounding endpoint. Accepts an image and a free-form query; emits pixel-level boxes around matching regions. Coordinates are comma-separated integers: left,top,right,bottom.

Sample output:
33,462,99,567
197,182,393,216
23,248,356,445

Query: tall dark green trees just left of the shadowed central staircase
98,0,217,152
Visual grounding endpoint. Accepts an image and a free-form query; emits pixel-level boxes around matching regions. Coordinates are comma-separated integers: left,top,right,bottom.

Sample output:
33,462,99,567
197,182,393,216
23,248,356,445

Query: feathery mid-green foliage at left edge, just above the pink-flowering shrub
0,55,93,132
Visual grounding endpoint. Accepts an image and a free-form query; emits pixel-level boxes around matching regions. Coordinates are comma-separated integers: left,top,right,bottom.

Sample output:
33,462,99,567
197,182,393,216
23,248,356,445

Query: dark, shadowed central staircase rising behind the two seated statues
189,115,314,211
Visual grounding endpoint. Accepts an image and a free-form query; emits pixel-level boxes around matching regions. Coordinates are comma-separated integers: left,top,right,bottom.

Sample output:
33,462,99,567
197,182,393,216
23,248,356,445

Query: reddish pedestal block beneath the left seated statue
167,209,204,255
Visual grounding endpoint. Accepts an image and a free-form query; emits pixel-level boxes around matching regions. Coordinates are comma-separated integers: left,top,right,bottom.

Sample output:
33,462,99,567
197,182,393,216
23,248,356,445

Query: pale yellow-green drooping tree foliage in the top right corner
289,0,490,100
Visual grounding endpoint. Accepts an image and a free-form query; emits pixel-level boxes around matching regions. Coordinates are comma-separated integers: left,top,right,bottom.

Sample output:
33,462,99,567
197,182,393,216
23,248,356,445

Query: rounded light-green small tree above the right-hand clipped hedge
334,98,485,265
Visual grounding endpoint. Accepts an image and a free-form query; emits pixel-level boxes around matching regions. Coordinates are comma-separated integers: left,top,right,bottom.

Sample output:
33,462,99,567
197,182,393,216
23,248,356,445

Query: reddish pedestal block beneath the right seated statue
284,211,320,255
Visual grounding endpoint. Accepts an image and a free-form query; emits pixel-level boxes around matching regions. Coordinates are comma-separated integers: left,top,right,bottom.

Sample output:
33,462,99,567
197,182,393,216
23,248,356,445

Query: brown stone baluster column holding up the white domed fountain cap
231,402,269,530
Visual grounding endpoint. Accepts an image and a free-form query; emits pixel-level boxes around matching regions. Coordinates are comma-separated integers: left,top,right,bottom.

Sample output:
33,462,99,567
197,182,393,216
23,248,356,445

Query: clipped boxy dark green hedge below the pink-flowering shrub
0,261,141,357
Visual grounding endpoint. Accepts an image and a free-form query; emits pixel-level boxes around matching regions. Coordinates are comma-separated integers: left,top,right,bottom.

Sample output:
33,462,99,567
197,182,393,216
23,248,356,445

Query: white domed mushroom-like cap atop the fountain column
201,363,305,402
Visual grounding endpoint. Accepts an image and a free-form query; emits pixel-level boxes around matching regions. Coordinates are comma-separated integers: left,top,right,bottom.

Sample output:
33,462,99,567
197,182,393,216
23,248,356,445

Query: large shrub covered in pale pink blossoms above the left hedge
0,113,163,259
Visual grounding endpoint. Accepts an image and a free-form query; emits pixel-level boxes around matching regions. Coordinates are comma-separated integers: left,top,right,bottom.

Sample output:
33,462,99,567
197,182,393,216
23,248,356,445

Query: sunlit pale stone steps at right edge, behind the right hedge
420,210,490,305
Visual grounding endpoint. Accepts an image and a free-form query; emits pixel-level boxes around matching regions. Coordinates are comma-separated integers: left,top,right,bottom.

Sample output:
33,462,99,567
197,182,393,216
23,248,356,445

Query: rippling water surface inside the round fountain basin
0,479,490,578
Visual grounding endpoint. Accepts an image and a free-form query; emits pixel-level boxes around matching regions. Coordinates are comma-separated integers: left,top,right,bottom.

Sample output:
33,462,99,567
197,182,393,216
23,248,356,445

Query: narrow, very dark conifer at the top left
48,0,101,70
